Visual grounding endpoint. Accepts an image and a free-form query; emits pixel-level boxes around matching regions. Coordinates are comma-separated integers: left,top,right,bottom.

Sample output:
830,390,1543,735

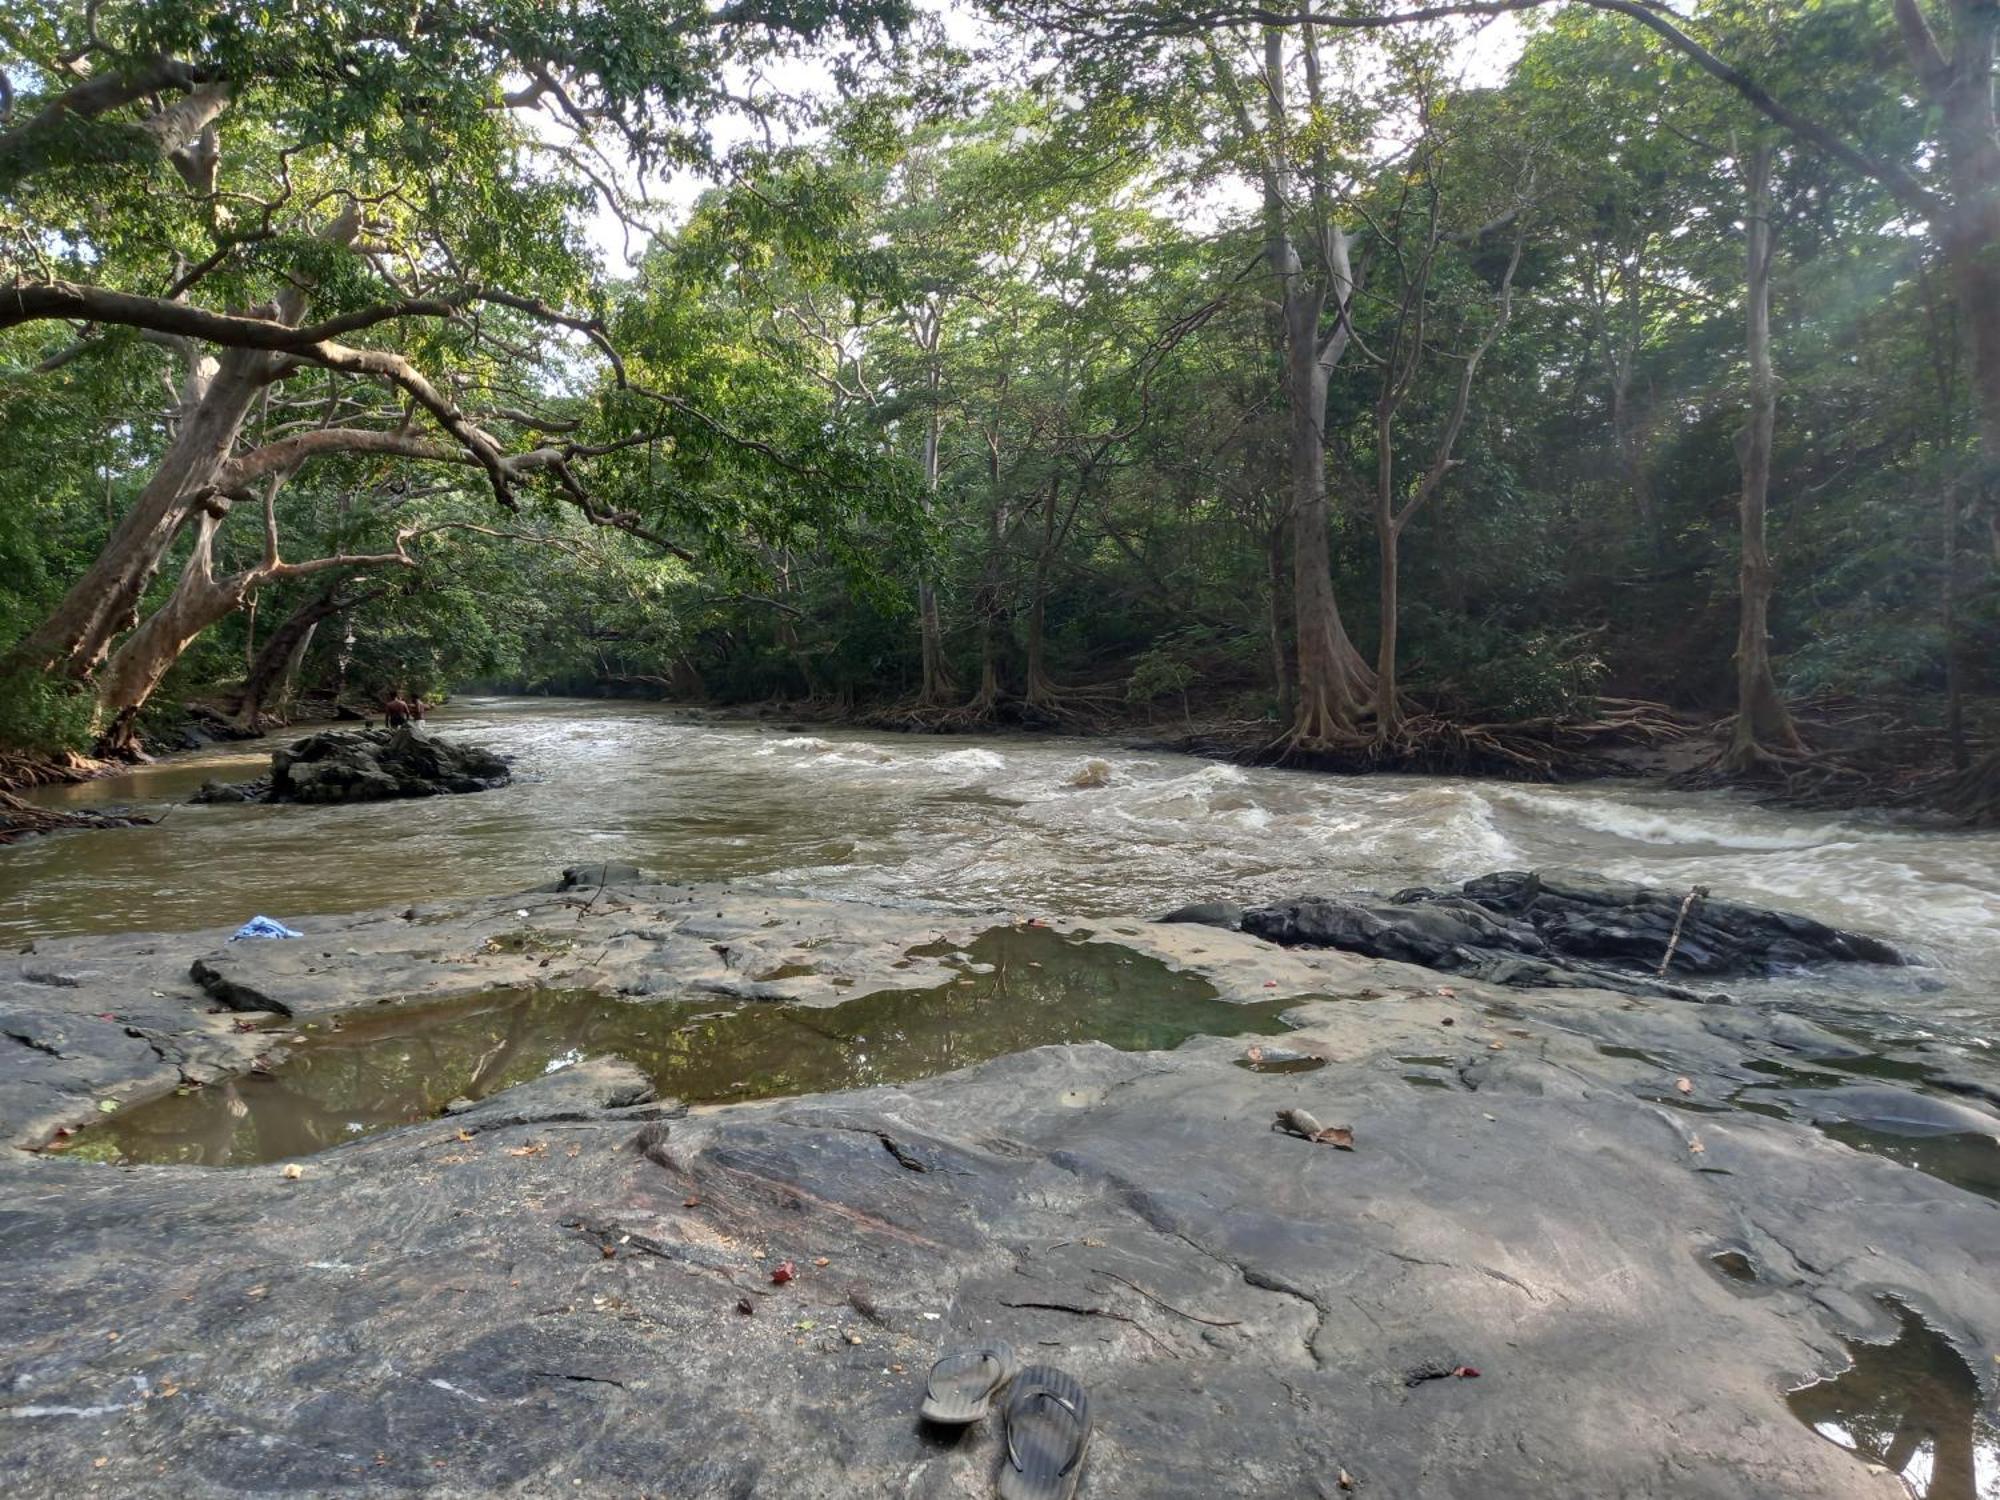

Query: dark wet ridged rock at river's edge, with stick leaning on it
1232,870,1904,996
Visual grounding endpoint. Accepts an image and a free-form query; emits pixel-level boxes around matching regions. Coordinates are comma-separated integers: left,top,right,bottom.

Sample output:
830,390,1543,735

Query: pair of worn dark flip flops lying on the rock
918,1344,1090,1500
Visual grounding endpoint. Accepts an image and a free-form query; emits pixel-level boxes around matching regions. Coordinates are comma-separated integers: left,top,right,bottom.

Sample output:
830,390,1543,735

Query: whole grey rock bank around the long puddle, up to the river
0,870,2000,1500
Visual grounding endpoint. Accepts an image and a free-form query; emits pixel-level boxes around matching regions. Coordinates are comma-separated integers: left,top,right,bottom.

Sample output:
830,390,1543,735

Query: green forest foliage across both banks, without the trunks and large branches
0,0,2000,764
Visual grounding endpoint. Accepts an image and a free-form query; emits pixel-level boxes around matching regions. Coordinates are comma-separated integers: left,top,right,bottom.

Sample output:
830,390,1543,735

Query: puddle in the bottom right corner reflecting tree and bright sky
1786,1302,2000,1500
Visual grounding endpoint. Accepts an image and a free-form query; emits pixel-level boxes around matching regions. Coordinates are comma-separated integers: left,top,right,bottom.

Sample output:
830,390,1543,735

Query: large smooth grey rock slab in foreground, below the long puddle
0,1028,2000,1500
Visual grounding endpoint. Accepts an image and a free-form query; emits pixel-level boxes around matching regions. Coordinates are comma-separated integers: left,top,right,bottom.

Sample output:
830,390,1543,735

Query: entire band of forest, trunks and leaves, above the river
0,0,2000,816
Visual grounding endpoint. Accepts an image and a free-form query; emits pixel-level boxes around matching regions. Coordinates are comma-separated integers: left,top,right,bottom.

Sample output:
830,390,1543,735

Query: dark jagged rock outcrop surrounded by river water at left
192,726,512,802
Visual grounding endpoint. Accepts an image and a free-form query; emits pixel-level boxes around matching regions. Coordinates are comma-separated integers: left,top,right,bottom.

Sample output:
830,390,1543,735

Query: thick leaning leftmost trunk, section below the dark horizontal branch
12,350,270,680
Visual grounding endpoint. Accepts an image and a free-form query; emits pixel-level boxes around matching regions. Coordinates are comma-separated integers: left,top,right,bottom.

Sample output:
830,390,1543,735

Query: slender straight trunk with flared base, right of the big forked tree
1724,146,1802,770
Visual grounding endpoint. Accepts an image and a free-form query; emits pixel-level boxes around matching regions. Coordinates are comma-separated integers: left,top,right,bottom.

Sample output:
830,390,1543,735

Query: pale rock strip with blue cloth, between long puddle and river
0,880,1000,1146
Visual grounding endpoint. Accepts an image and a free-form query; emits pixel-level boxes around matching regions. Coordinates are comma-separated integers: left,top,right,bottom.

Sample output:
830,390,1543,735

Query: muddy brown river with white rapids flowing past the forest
0,698,2000,1050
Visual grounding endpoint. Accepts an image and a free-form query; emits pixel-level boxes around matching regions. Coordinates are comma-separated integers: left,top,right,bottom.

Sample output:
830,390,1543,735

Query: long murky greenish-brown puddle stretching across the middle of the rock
64,928,1298,1166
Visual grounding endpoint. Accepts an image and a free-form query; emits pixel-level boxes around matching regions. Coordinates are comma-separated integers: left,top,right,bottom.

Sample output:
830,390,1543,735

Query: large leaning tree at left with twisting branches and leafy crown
0,0,904,748
